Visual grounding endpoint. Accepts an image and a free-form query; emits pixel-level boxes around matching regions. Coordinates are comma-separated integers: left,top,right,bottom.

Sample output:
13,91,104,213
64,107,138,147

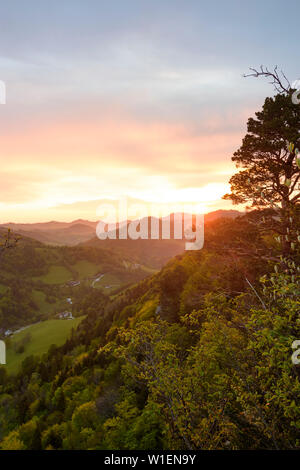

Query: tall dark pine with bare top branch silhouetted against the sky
224,69,300,255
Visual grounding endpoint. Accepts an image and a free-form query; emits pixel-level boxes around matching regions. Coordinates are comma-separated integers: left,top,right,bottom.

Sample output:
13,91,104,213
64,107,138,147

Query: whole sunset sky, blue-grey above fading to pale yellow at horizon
0,0,300,223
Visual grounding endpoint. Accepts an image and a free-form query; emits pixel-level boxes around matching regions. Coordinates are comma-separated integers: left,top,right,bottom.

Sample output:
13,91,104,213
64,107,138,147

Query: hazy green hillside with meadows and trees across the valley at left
0,232,149,335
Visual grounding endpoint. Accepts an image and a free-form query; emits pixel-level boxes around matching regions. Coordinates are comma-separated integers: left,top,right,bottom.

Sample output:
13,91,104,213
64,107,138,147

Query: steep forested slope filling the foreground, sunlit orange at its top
0,212,300,449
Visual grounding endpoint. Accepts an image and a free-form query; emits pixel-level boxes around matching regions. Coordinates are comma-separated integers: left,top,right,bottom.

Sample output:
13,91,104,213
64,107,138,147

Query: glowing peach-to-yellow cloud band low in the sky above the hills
0,115,241,220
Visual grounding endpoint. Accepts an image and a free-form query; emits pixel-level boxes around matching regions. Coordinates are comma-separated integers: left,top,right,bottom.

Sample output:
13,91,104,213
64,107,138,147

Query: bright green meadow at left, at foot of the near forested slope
5,317,83,374
